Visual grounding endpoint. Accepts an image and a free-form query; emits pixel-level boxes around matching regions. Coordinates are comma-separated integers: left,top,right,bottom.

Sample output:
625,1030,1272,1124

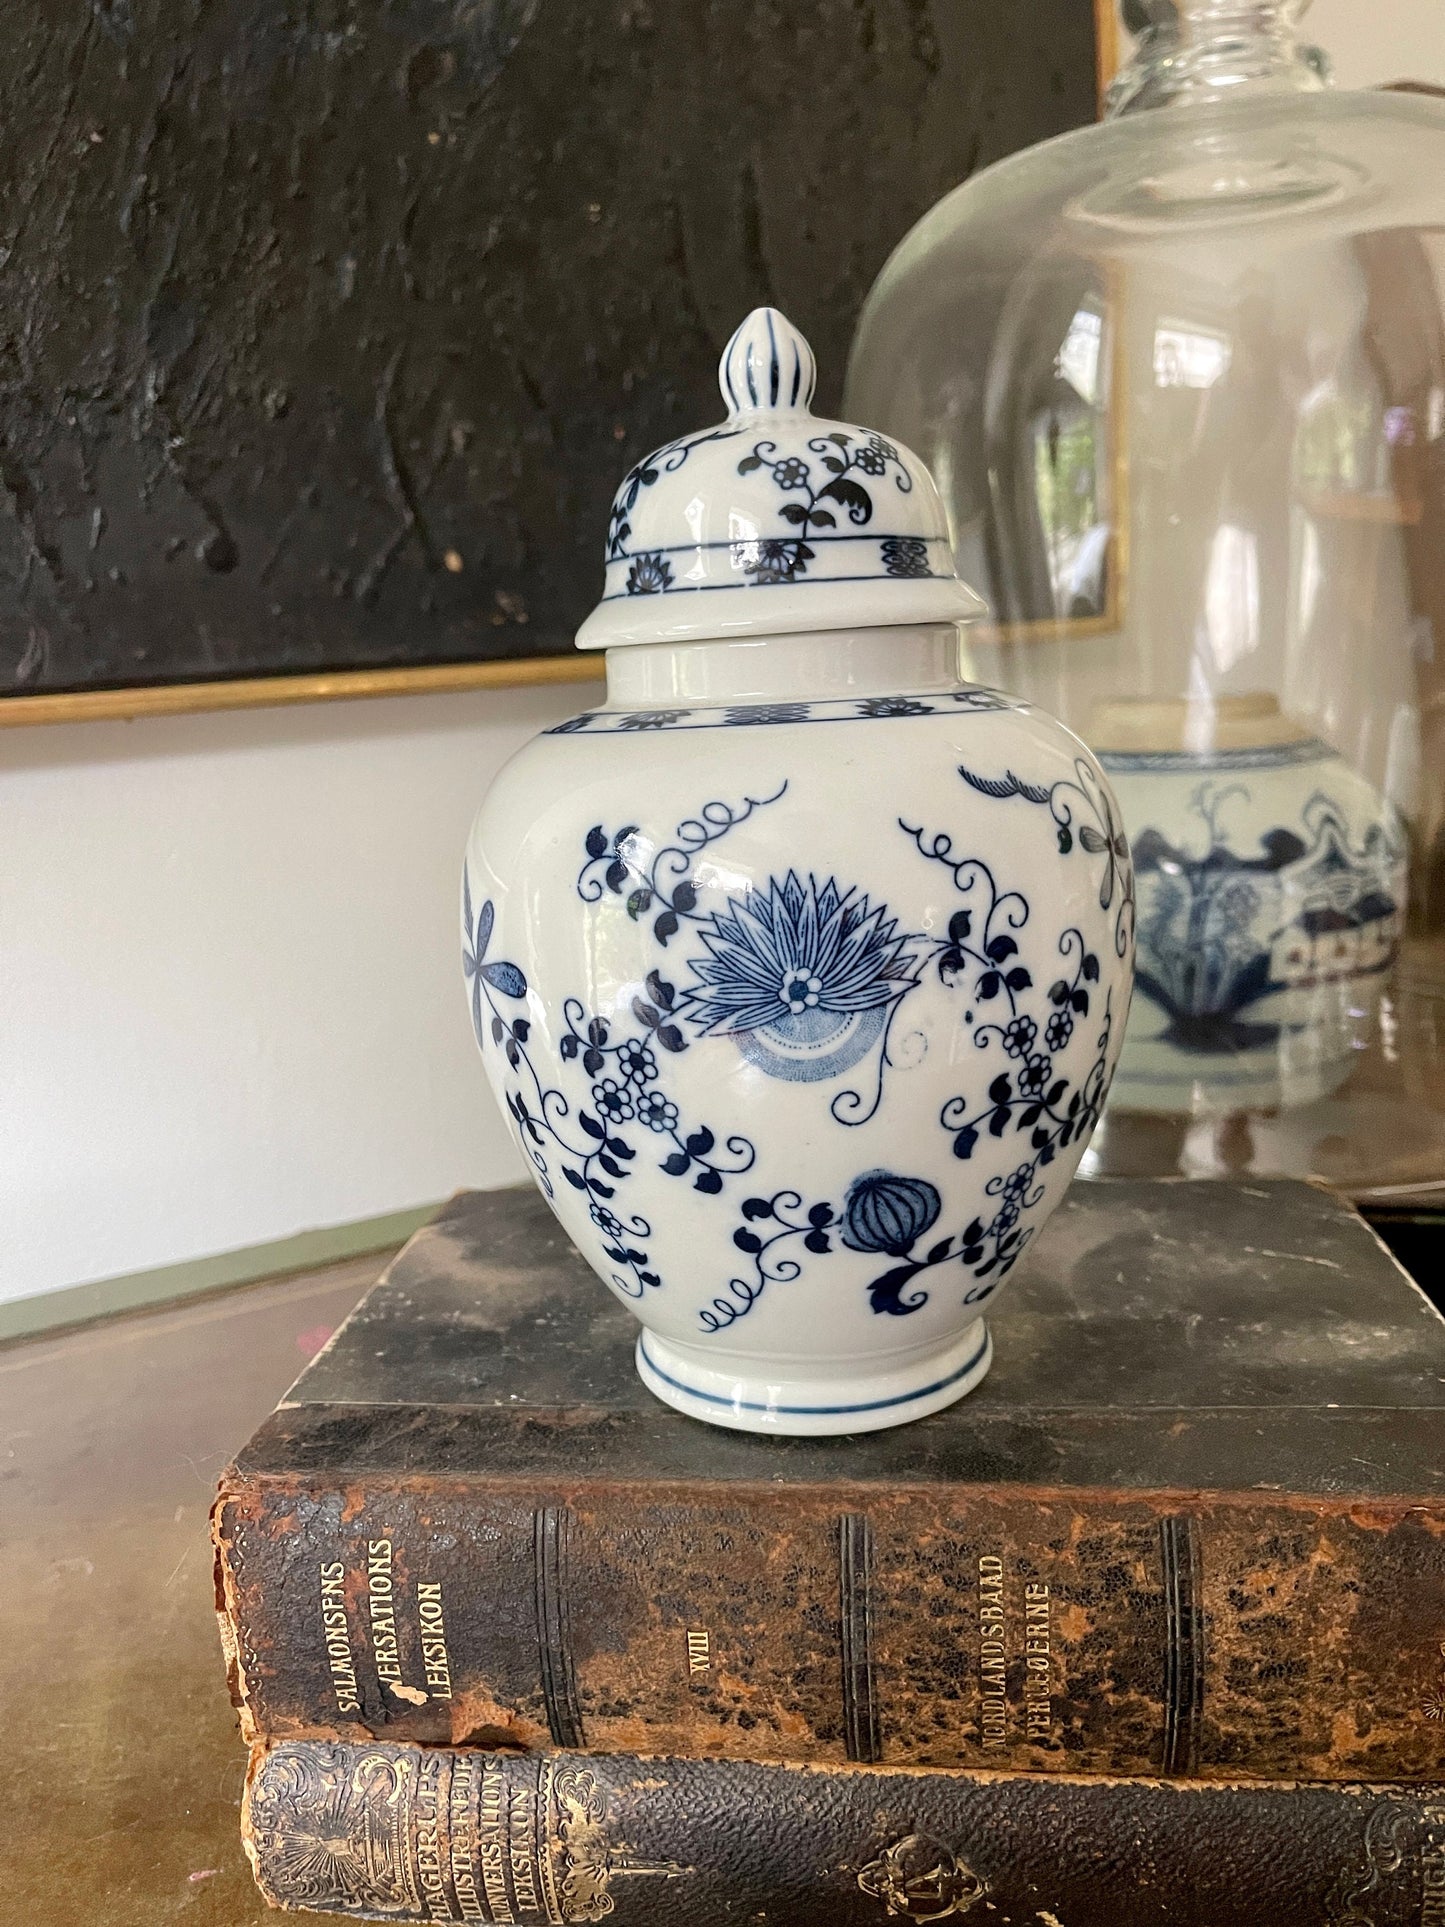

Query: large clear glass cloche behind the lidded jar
848,0,1445,1202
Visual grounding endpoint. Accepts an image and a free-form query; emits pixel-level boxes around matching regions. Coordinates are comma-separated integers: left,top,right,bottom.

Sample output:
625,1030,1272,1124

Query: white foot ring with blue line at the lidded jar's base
638,1318,994,1438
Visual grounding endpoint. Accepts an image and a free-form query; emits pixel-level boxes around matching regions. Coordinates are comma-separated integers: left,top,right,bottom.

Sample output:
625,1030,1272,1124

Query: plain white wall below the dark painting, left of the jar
0,686,591,1299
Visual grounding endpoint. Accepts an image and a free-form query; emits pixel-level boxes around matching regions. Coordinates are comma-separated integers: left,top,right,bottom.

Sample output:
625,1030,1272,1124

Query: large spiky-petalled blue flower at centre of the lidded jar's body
682,871,919,1083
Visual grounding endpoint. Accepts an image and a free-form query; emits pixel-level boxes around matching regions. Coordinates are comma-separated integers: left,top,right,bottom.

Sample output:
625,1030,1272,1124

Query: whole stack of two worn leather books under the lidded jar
216,1183,1445,1927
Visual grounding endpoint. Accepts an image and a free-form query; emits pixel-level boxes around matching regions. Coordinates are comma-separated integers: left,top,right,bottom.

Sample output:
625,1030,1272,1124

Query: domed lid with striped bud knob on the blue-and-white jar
576,308,985,649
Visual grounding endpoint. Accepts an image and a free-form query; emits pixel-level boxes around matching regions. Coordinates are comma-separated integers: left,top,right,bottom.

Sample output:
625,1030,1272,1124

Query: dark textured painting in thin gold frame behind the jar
0,0,1104,725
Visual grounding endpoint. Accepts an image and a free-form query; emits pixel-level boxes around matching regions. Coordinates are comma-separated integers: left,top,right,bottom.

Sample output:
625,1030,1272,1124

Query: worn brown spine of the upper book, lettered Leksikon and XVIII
216,1474,1445,1781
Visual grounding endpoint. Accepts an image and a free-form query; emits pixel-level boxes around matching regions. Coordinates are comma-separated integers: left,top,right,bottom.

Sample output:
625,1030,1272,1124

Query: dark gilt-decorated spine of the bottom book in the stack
243,1740,1445,1927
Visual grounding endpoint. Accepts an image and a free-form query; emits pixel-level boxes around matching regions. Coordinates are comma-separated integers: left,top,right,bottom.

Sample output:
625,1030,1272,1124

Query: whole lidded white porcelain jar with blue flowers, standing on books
462,308,1133,1434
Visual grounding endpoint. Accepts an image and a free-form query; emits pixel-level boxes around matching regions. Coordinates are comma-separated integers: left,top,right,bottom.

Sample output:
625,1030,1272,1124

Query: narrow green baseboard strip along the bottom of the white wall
0,1201,439,1343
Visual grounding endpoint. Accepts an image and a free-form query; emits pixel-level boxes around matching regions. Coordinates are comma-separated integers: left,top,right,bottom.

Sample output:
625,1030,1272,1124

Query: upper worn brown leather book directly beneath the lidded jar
216,1183,1445,1781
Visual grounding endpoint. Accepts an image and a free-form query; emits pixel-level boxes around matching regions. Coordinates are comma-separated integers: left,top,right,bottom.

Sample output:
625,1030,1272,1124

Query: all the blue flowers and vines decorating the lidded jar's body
481,759,1133,1333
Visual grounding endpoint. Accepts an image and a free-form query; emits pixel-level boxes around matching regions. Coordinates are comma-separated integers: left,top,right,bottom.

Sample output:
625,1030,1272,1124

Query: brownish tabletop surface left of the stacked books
0,1254,396,1927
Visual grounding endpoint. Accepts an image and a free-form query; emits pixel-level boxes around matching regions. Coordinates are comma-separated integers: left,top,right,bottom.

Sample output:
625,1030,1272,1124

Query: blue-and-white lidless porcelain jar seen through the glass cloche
1100,732,1405,1114
